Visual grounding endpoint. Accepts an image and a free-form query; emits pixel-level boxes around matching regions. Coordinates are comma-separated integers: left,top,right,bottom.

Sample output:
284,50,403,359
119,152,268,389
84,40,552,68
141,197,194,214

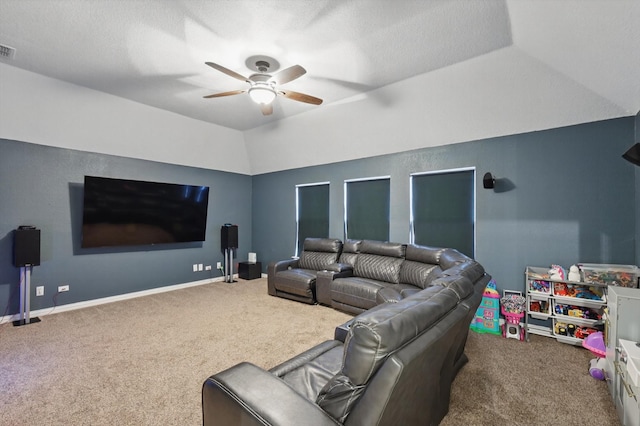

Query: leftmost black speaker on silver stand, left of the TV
13,225,40,326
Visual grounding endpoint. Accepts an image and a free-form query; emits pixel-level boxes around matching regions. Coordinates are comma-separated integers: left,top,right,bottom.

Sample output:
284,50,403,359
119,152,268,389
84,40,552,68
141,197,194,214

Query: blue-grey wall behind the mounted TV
0,139,252,316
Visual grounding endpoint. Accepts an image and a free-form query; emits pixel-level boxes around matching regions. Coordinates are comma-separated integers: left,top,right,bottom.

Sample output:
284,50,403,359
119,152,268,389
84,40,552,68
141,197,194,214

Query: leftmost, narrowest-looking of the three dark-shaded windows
296,182,329,256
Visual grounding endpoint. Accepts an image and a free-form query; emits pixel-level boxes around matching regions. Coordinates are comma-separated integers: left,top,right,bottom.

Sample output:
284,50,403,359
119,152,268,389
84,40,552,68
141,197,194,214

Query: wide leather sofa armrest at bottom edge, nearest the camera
202,362,340,426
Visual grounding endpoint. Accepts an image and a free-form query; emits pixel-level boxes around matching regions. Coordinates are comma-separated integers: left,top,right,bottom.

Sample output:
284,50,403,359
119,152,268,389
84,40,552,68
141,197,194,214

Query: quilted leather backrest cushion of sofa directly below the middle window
353,240,406,284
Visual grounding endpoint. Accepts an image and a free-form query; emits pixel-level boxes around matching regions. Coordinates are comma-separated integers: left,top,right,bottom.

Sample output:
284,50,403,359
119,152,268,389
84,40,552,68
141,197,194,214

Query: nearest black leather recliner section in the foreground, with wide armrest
202,276,480,426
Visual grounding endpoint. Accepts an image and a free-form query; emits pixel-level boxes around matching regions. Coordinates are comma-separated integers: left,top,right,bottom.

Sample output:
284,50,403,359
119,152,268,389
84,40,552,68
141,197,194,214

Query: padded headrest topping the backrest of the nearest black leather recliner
342,286,458,386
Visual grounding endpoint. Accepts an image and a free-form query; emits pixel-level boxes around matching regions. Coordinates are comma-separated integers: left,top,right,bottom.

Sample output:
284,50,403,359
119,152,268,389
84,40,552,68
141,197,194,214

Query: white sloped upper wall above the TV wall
0,63,250,174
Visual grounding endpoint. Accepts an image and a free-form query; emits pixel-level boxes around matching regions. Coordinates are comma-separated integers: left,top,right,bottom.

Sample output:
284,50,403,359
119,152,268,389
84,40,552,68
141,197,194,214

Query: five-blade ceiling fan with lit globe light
203,56,322,115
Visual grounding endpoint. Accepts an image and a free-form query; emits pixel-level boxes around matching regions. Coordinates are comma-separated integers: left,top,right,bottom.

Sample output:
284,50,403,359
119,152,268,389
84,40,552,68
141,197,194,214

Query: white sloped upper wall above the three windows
245,47,628,175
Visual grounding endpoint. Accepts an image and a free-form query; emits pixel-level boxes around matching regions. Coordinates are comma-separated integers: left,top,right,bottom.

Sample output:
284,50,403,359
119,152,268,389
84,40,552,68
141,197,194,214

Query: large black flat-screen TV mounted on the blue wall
81,176,209,248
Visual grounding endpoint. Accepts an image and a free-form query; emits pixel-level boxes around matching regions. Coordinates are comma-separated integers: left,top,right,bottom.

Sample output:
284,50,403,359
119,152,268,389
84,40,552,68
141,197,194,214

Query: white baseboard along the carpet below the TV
0,274,238,324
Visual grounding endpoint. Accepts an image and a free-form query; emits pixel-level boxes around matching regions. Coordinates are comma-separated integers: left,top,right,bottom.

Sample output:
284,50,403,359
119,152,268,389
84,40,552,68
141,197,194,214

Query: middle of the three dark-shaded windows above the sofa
344,177,390,241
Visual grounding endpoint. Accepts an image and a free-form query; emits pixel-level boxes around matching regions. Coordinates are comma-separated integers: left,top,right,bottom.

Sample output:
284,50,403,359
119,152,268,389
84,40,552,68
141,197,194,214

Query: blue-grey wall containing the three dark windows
252,117,640,290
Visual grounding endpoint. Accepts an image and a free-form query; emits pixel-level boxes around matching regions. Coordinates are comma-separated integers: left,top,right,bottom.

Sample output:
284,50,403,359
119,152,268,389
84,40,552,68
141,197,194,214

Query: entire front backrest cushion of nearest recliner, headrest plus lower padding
316,286,458,421
